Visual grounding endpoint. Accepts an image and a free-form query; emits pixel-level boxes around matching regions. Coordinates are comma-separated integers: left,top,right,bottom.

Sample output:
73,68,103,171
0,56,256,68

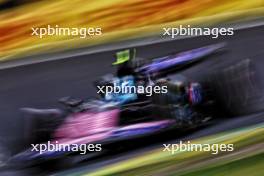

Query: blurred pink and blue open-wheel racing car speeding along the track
7,44,223,168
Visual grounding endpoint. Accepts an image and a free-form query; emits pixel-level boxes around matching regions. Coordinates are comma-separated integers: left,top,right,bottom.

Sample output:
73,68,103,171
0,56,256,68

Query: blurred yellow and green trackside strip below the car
81,124,264,176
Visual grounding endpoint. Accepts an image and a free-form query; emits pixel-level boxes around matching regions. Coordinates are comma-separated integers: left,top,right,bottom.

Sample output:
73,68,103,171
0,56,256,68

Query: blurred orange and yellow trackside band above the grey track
0,0,264,60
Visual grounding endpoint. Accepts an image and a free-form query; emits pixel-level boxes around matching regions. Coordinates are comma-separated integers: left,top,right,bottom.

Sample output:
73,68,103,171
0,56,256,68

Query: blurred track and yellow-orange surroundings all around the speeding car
0,0,264,176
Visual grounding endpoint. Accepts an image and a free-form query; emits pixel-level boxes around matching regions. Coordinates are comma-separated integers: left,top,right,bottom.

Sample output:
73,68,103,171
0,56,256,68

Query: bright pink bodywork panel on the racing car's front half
54,109,120,144
